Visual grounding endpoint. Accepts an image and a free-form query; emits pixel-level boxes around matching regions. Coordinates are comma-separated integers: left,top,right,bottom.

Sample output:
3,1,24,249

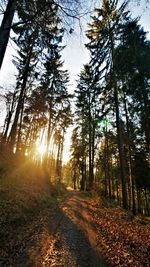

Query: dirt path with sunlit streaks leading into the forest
43,192,108,267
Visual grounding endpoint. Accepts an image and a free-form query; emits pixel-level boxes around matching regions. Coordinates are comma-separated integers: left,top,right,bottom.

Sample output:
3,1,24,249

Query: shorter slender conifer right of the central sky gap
75,64,99,189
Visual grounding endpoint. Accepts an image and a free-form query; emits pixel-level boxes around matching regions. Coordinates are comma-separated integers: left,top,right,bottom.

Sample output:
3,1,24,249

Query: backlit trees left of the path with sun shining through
0,0,81,179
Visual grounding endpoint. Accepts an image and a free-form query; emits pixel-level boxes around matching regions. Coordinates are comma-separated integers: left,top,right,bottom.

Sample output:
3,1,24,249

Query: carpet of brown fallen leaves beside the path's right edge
86,202,150,267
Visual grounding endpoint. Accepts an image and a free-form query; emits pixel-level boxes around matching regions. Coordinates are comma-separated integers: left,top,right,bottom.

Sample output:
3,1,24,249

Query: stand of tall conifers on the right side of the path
71,0,150,217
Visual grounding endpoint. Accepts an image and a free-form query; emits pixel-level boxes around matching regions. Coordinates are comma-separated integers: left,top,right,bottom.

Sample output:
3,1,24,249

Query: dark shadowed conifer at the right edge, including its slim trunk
113,20,150,214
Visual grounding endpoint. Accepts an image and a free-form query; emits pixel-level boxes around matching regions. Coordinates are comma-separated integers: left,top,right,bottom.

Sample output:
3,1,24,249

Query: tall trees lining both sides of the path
0,0,150,214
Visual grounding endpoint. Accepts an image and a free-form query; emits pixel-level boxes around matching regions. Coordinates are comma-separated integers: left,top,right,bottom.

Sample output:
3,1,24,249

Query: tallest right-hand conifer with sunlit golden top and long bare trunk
87,0,128,209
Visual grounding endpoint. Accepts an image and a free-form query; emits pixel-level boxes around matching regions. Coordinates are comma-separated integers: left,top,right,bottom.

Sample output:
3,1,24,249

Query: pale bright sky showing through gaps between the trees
0,0,150,161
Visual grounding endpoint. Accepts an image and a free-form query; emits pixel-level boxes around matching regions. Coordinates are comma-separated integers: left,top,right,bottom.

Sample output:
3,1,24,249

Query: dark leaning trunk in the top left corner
0,0,17,69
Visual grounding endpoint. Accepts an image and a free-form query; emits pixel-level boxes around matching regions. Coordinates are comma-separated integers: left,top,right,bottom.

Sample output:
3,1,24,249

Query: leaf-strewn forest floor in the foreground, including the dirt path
0,191,150,267
